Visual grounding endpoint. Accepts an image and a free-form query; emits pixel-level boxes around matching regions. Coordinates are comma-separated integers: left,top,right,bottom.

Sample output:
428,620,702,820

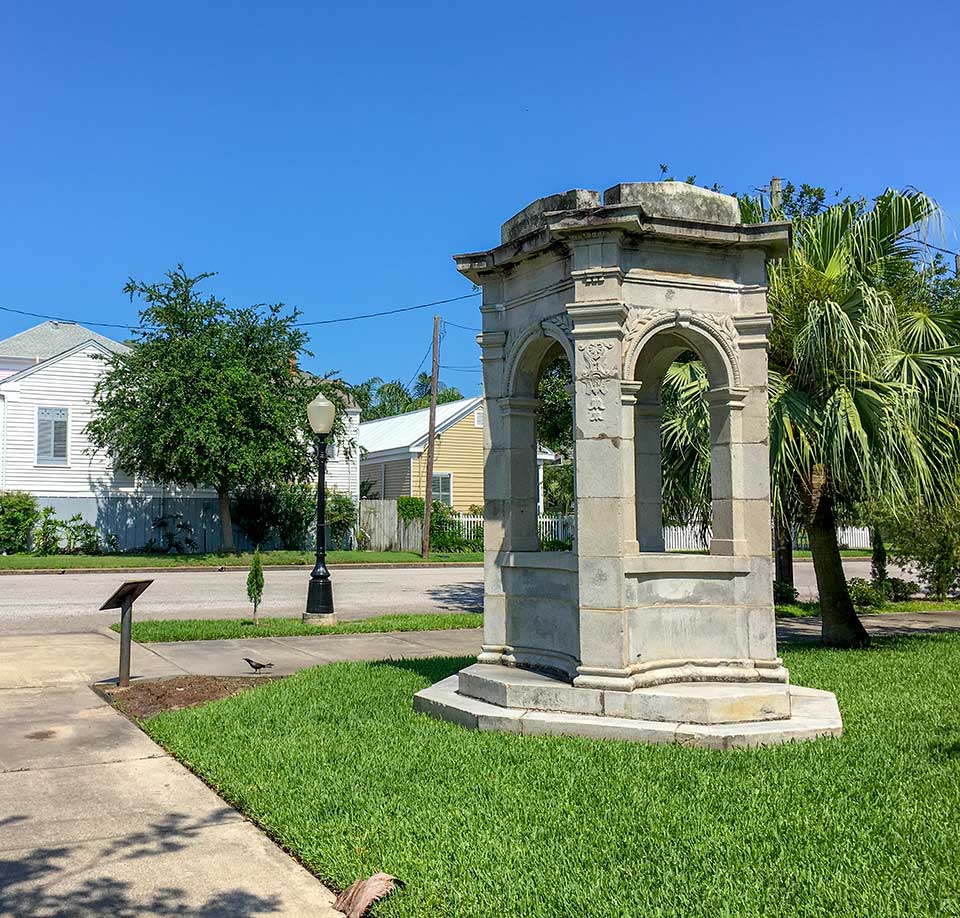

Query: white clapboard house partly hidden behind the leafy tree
0,322,360,551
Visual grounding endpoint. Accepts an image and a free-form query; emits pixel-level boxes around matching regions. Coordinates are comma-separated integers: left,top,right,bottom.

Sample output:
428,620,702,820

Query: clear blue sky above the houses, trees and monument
0,0,960,394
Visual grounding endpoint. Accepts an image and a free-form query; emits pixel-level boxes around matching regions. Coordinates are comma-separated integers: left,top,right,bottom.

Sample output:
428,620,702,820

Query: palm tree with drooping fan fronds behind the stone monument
662,190,960,647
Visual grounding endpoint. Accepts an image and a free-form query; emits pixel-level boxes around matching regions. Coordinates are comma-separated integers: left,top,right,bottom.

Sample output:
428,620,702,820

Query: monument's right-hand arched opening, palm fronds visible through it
634,325,740,554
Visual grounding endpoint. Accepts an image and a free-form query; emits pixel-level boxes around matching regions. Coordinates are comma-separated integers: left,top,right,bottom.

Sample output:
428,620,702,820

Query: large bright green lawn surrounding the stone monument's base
146,634,960,918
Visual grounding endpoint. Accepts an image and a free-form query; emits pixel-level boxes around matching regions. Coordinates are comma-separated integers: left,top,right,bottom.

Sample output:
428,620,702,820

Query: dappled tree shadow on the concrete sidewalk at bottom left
0,808,284,918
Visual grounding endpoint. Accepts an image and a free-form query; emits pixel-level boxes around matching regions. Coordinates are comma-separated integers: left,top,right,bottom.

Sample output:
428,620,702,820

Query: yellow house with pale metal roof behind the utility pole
359,395,552,513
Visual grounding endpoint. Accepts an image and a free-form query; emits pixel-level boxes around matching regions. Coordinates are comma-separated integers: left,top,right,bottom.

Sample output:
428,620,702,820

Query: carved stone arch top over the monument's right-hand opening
623,309,743,389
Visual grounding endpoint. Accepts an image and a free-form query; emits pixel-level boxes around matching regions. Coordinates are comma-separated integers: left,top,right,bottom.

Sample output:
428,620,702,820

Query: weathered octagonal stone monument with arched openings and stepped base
414,182,842,749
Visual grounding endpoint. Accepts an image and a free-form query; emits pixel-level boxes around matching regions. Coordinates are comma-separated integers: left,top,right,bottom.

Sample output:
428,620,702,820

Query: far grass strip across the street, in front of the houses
0,551,483,571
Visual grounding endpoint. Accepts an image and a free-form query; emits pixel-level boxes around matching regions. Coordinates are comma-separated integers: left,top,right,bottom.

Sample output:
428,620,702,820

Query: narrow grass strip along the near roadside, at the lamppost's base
110,612,483,643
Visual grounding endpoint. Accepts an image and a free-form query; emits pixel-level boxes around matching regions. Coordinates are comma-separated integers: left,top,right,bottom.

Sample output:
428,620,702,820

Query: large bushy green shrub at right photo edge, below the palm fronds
890,507,960,601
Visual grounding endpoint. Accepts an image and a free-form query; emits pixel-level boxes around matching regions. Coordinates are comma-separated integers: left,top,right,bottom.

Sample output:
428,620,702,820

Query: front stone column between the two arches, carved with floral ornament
568,302,629,689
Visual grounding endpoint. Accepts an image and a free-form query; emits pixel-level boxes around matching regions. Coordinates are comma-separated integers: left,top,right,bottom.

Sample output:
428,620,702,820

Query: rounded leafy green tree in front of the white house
87,265,344,551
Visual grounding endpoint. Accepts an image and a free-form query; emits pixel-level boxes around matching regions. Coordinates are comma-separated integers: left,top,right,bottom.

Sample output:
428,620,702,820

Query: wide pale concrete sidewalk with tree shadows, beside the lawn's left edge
0,634,340,918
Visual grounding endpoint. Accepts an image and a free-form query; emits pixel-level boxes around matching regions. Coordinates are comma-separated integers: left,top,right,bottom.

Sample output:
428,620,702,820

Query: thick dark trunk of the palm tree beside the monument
807,495,870,647
